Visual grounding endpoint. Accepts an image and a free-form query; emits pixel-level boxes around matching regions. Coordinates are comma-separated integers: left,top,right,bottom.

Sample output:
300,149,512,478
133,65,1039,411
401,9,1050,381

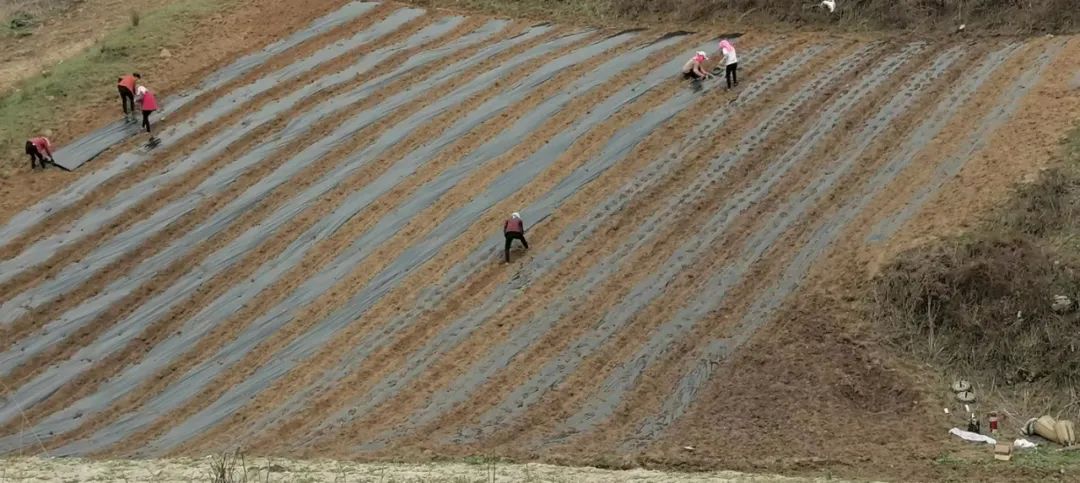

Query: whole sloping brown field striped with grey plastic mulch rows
0,3,1080,464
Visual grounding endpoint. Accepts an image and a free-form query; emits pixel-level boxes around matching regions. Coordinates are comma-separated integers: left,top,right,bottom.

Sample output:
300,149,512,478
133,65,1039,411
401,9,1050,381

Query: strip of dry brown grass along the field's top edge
403,0,1080,33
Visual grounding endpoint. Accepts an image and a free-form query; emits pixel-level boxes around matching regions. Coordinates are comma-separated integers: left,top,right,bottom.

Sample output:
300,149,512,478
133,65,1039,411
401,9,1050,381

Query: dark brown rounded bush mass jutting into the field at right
875,234,1080,387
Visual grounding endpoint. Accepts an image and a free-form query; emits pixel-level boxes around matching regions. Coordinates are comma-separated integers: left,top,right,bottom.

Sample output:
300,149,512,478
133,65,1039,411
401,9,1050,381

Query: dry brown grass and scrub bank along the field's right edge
874,122,1080,418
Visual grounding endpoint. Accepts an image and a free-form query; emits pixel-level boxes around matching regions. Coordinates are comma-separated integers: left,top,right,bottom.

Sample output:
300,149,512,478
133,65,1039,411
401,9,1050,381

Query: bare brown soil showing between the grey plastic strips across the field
0,0,1080,480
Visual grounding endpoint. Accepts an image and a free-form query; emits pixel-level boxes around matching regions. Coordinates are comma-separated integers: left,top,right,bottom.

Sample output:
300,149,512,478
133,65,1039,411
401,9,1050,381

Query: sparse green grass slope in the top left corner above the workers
0,0,228,173
